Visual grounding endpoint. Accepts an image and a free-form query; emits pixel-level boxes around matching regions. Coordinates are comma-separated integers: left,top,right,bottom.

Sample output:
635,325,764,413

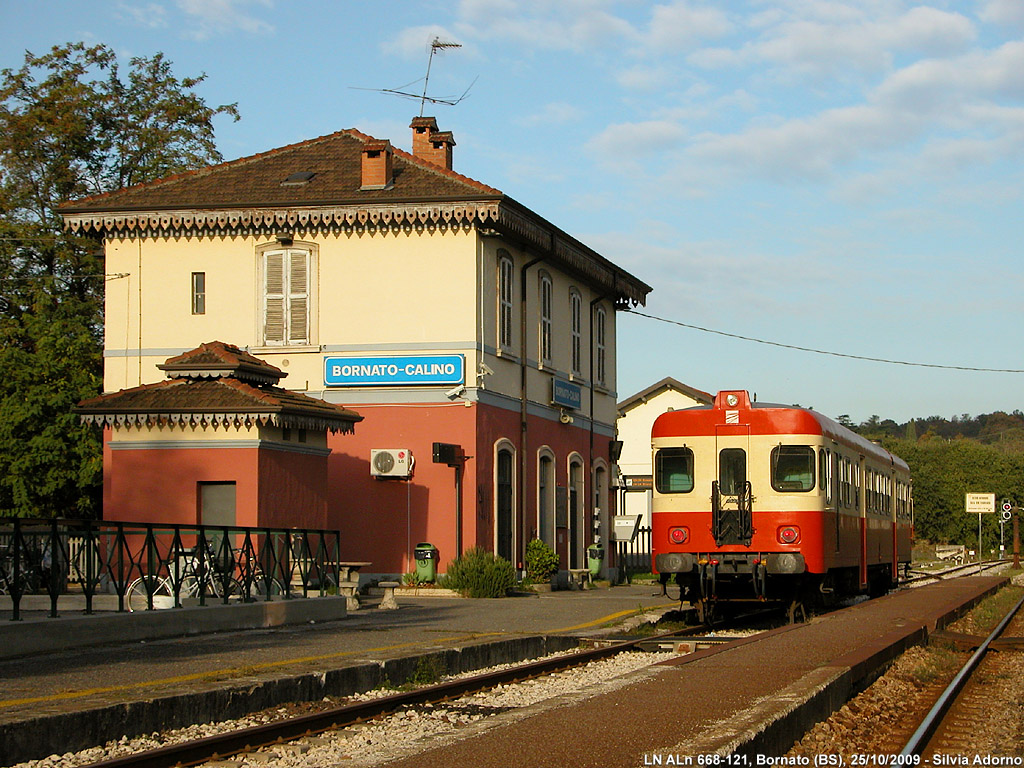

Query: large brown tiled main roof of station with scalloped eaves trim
58,121,651,305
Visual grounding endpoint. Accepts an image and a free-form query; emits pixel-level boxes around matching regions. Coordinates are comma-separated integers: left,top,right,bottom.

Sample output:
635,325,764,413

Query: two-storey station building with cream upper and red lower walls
60,118,651,574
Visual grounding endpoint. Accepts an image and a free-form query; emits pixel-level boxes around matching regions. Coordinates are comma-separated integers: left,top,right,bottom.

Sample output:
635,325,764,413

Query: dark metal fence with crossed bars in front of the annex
0,518,342,621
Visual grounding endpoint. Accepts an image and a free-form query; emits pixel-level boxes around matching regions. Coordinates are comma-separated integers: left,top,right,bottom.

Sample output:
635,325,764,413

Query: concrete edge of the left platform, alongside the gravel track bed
0,635,580,765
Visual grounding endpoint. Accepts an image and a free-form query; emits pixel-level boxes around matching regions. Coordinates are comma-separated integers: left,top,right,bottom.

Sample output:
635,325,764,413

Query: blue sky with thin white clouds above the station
0,0,1024,422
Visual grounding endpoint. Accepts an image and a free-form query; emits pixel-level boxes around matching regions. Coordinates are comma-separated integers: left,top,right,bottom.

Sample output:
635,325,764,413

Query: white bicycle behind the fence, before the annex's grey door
125,547,242,612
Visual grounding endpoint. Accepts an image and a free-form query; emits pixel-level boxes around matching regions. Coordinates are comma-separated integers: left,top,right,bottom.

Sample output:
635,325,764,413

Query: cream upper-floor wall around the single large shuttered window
104,230,477,391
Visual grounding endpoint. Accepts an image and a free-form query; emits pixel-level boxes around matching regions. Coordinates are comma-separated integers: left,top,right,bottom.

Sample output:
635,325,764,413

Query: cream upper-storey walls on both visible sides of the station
103,224,615,434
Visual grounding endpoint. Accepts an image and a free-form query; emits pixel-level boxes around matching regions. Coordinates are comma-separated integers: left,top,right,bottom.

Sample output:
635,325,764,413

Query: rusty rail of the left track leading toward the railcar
81,627,729,768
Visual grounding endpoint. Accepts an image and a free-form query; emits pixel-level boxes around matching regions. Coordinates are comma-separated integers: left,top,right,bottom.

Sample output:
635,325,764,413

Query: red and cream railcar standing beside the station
651,390,913,617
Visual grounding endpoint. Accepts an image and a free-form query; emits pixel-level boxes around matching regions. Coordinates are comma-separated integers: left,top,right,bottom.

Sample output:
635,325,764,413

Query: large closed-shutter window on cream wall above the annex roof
260,248,313,346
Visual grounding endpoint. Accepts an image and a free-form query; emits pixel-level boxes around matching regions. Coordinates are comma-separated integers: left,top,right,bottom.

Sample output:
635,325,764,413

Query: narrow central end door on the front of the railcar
712,434,754,547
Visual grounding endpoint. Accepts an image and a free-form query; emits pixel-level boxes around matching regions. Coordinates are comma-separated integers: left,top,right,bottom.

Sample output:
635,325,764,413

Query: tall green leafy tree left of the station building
0,43,238,516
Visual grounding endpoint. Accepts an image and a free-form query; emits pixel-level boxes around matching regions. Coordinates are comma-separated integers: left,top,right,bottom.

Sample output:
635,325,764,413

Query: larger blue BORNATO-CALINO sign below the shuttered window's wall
324,354,466,387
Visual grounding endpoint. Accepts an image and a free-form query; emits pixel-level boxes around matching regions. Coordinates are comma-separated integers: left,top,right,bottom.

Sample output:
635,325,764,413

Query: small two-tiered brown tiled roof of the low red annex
74,341,362,432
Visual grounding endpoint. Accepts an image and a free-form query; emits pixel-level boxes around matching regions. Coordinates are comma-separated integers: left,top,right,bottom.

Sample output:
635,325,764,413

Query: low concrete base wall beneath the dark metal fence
0,596,347,658
